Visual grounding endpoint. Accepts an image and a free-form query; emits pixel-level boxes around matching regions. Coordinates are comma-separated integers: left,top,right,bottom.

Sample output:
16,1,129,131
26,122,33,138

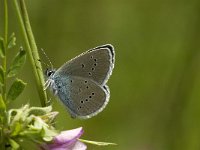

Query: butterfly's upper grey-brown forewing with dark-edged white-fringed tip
56,44,115,85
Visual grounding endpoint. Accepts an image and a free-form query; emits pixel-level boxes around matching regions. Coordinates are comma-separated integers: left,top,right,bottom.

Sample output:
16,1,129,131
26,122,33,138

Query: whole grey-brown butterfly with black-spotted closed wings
46,45,114,119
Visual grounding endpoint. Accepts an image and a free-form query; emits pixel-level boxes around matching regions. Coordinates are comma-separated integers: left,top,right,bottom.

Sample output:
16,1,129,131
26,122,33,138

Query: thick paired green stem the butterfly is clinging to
13,0,48,107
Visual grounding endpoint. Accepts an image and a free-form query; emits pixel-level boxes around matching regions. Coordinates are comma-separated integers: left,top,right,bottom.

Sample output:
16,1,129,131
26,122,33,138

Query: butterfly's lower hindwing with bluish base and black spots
54,74,110,119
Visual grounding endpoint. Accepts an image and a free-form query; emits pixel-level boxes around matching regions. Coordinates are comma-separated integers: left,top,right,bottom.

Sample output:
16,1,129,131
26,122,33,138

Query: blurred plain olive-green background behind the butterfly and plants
0,0,200,150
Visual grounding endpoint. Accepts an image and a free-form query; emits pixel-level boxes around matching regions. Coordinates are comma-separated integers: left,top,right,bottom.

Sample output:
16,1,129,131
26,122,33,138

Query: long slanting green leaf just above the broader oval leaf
7,49,26,77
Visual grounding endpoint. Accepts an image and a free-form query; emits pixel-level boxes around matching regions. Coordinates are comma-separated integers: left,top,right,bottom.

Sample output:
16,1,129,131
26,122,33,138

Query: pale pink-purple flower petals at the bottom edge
42,127,87,150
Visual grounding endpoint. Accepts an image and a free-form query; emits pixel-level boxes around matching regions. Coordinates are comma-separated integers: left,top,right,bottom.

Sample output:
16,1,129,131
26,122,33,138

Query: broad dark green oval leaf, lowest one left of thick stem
7,79,26,100
